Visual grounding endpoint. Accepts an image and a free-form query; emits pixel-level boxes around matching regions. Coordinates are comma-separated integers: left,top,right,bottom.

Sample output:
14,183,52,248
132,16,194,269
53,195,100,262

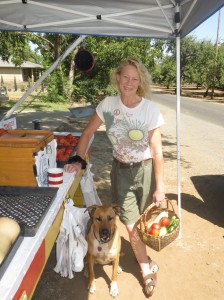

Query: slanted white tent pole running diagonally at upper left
1,35,86,121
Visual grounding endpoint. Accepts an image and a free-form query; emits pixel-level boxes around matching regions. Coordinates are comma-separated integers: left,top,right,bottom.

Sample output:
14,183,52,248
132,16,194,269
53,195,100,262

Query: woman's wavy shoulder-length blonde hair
111,57,152,97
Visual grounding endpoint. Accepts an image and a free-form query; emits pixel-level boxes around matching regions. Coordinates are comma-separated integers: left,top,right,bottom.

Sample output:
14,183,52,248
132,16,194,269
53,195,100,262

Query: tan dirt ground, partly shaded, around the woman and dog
11,89,224,300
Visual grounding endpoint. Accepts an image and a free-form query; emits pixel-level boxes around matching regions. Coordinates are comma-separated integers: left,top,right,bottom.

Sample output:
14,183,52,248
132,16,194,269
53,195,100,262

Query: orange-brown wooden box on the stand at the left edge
0,129,54,186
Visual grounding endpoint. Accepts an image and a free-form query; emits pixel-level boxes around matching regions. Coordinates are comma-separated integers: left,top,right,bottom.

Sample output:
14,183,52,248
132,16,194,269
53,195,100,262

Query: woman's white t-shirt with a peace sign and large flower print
96,96,164,163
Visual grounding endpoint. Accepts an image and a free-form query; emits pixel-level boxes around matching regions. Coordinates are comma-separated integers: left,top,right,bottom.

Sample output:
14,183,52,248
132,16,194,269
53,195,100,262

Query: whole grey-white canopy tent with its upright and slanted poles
0,0,224,236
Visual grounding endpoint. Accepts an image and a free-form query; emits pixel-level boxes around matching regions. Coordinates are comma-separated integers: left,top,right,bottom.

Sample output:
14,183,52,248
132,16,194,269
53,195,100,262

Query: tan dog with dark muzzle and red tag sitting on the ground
86,205,122,297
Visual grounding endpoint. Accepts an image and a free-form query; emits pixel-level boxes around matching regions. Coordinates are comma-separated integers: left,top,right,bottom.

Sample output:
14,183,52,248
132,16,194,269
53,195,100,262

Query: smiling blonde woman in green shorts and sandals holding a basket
65,58,165,296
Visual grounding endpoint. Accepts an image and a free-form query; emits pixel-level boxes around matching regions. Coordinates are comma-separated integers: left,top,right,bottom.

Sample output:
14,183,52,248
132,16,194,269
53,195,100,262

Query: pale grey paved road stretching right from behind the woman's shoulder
153,93,224,127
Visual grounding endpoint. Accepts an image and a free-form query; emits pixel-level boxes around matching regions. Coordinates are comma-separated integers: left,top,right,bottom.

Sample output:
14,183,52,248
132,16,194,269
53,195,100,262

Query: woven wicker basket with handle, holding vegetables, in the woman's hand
136,200,180,251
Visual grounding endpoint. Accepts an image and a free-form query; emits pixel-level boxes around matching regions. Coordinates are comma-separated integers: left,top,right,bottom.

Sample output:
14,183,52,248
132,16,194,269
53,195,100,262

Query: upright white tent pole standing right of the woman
176,36,182,237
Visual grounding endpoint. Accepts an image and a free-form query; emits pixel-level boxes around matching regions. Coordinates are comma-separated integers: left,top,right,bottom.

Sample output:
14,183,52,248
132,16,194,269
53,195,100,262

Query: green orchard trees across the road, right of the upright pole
163,36,224,94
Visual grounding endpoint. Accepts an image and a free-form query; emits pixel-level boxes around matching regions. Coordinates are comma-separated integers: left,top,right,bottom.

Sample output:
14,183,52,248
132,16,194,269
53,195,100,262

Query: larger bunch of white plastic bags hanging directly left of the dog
54,199,90,279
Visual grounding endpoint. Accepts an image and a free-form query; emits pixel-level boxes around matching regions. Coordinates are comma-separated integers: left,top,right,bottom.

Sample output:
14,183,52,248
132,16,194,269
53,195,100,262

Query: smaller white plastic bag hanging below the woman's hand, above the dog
80,163,102,207
